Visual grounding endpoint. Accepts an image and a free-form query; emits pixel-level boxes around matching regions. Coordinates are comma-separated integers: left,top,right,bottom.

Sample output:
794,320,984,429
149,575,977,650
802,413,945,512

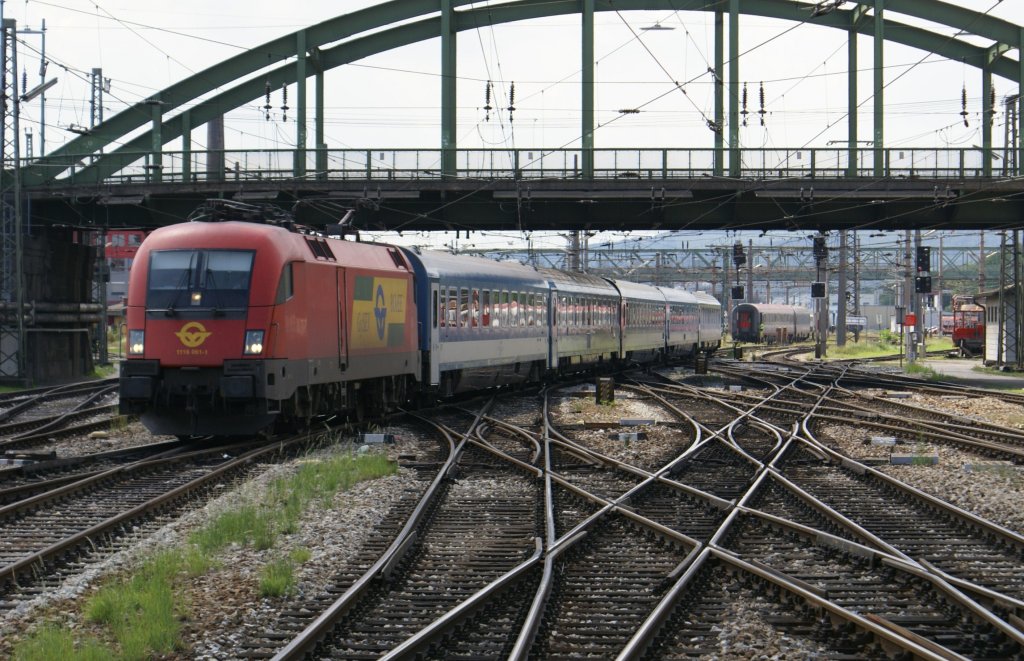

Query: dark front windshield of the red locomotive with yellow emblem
145,250,254,316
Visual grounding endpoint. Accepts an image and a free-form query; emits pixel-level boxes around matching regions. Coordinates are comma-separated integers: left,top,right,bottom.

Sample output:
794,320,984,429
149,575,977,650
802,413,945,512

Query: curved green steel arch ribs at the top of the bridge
14,0,1024,194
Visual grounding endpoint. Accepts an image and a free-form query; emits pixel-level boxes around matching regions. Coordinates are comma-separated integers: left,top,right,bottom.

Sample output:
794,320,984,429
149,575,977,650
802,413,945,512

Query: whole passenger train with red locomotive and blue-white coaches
120,221,722,436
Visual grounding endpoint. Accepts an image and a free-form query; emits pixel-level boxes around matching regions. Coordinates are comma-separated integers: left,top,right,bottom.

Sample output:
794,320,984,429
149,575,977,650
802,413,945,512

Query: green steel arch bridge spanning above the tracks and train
6,0,1024,235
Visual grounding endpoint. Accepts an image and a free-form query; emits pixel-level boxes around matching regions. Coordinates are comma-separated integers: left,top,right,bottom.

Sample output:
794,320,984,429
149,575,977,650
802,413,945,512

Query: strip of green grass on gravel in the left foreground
14,451,397,661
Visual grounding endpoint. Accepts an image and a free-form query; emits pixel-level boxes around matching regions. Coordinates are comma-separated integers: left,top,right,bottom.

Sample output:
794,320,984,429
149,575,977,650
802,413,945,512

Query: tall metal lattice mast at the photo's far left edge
0,18,25,379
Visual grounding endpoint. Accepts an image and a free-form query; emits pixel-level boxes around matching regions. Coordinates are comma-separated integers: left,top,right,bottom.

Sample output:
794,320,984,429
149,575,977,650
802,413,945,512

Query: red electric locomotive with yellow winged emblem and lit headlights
121,222,420,436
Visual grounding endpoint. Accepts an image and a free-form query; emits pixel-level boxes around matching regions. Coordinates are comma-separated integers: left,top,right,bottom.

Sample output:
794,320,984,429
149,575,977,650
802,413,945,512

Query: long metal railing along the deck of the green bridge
36,147,1003,186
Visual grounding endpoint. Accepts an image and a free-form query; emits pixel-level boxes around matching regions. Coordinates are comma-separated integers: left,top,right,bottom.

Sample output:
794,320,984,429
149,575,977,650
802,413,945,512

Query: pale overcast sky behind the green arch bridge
0,0,1024,254
